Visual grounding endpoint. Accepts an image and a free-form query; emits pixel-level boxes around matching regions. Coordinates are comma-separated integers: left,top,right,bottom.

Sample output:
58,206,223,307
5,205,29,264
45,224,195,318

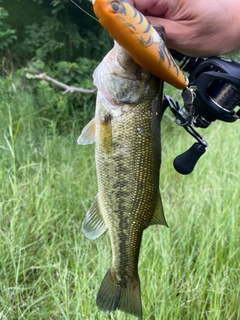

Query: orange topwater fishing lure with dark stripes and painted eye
92,0,188,89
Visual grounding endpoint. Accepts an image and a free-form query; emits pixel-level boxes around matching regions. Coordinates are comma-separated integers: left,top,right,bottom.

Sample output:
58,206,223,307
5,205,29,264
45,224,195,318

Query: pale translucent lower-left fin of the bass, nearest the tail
82,196,107,240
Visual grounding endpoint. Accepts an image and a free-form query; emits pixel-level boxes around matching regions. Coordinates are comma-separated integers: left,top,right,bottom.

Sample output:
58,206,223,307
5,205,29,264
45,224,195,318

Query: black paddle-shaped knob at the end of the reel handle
173,142,206,174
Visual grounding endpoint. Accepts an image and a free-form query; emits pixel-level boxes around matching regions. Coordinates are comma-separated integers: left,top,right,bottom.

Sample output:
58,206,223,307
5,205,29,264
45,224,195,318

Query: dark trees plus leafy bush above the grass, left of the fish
0,0,107,125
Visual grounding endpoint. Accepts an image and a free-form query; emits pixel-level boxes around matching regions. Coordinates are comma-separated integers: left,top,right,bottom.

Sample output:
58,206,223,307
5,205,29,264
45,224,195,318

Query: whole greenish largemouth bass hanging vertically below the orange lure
78,41,167,319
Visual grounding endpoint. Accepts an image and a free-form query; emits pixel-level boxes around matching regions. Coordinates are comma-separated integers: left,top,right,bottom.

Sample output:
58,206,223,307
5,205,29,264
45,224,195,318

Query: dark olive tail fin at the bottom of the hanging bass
96,268,142,319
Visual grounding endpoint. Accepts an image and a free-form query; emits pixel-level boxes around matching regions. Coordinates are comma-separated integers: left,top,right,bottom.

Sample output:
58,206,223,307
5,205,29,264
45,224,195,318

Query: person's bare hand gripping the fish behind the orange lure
128,0,240,57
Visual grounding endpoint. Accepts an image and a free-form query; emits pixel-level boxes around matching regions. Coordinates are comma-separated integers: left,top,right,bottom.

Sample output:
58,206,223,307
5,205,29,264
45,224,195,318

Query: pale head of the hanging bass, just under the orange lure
93,42,160,109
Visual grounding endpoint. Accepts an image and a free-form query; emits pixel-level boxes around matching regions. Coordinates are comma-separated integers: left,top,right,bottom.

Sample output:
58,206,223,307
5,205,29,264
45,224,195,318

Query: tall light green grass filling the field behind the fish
0,75,240,320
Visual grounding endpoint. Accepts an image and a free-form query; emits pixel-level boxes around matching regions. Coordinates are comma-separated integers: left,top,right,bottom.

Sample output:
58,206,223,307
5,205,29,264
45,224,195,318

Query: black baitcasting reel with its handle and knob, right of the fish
162,50,240,174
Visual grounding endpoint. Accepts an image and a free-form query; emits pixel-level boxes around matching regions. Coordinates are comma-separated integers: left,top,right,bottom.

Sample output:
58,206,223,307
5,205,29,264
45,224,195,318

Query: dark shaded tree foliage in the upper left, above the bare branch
0,0,111,66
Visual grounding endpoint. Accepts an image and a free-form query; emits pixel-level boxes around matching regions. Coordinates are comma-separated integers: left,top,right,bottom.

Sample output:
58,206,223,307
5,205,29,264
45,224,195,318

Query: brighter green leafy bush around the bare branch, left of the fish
22,57,98,132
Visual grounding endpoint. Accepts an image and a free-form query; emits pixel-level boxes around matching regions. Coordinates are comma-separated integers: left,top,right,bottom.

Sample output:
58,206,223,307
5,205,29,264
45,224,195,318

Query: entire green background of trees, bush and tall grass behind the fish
0,0,240,320
